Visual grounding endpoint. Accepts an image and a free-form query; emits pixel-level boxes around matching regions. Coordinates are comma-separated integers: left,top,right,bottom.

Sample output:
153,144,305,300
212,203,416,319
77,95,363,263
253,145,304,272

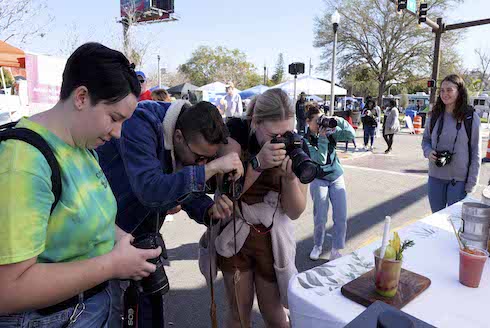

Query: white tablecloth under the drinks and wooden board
288,202,490,328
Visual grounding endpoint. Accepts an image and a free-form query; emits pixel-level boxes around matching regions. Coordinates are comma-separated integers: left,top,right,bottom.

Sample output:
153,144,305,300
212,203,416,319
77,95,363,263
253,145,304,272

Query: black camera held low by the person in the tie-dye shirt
133,232,170,295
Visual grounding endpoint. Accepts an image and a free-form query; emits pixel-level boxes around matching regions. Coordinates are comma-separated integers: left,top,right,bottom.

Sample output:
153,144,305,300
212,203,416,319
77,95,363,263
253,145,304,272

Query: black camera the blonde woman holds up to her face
271,131,319,184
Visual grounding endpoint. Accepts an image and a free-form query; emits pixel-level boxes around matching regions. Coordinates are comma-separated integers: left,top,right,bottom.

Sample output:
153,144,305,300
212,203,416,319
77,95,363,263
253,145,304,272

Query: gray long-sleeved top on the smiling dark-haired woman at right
422,113,481,193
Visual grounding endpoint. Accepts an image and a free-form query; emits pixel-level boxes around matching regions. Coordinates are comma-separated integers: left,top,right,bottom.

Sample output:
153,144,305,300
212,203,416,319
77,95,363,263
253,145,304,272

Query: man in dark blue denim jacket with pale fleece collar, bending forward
97,100,243,328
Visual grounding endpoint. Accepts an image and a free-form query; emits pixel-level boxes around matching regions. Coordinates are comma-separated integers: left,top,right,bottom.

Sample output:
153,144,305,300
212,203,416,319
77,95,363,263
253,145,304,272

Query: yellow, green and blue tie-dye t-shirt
0,118,117,264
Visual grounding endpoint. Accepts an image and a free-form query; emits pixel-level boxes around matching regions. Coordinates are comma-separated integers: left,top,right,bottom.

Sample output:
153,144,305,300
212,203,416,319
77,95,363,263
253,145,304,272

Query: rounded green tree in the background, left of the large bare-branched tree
178,46,262,89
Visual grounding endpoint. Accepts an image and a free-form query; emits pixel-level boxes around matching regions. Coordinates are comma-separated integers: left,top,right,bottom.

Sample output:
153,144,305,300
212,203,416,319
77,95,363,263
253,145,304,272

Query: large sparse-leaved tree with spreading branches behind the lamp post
314,0,459,101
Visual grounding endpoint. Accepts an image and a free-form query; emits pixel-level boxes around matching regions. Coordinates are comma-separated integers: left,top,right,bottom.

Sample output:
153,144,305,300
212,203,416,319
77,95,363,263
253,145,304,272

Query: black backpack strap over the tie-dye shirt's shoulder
0,122,61,213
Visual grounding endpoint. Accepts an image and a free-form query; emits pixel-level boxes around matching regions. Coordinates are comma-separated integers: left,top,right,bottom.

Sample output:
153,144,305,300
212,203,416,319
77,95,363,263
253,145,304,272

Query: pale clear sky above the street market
10,0,490,76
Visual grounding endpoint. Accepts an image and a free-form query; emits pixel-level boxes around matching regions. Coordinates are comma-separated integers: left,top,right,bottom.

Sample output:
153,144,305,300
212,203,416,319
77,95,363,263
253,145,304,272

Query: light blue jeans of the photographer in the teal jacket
310,175,347,249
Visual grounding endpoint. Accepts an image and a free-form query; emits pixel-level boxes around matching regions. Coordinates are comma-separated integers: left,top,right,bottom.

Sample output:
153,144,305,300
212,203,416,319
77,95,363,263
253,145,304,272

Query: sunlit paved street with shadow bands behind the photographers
162,130,490,328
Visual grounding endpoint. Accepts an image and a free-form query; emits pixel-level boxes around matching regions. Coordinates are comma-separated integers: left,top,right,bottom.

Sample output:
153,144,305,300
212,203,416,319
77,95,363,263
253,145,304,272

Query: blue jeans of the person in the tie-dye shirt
0,288,111,328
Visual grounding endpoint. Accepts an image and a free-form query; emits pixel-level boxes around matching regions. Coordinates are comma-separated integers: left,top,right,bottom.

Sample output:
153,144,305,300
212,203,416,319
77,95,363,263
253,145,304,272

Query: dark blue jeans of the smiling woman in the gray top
428,176,466,213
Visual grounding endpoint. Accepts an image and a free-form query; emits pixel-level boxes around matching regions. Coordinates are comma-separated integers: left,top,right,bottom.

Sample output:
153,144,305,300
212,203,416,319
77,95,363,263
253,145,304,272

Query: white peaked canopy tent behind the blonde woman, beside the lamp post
272,75,347,98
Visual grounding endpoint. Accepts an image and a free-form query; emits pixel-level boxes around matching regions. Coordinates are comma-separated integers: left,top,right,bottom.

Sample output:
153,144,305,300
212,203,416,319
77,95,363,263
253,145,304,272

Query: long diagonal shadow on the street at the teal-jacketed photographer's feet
296,184,427,272
